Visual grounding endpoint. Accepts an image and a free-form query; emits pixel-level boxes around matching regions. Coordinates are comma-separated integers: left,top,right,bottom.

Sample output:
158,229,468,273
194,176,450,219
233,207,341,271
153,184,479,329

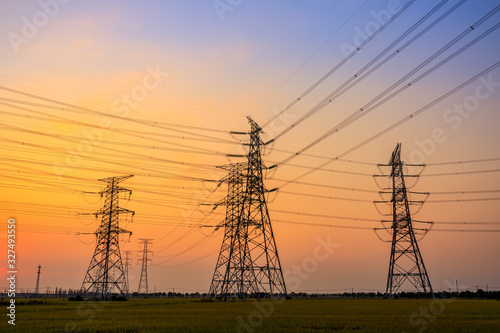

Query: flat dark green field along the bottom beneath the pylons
0,299,500,332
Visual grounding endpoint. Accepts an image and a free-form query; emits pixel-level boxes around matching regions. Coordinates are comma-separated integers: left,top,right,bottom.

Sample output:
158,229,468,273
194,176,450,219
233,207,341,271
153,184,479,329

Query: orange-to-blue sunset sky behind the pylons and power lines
0,0,500,292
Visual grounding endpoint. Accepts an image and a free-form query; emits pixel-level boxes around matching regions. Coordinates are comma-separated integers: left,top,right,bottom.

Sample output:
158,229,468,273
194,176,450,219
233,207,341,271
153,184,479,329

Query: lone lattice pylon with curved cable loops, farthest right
376,143,434,298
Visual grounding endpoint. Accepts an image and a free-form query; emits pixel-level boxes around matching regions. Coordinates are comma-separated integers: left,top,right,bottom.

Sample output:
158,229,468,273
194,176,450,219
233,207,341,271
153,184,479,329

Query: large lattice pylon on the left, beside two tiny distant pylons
81,175,134,299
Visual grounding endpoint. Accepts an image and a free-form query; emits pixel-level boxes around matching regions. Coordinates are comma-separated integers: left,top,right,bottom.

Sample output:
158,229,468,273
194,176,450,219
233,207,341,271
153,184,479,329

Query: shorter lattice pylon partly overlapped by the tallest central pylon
208,163,258,299
